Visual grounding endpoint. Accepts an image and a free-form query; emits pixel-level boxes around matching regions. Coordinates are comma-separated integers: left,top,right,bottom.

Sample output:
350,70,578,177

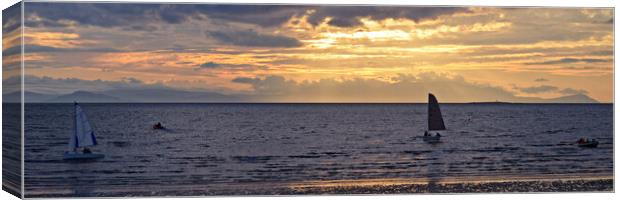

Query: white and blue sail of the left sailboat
69,103,97,151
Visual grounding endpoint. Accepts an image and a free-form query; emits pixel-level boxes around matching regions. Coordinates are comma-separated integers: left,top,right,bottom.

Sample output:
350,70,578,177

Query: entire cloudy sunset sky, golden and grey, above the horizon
3,2,614,102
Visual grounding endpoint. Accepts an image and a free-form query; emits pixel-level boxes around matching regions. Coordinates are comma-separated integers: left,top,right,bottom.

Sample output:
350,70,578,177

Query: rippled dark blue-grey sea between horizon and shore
24,103,614,197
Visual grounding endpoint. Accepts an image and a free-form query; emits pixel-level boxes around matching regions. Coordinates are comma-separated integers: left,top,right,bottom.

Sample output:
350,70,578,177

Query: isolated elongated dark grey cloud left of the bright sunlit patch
207,30,301,47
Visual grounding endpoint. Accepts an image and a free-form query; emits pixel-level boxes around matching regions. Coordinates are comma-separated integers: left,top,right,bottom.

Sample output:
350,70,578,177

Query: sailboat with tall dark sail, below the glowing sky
423,93,446,143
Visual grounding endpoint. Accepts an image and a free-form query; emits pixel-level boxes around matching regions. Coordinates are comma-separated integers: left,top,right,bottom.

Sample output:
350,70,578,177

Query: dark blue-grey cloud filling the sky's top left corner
26,2,306,28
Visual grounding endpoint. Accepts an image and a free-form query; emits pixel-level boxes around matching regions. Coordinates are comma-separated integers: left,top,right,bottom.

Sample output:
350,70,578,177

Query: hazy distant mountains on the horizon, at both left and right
2,89,599,103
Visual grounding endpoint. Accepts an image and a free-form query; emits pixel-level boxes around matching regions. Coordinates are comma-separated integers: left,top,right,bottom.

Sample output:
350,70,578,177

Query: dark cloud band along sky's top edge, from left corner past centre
27,2,469,27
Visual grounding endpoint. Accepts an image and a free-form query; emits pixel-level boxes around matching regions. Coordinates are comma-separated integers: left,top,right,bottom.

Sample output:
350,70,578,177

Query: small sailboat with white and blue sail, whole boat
63,102,105,161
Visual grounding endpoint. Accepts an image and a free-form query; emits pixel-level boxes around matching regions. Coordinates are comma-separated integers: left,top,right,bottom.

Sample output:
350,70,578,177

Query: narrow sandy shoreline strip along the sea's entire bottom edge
26,176,614,198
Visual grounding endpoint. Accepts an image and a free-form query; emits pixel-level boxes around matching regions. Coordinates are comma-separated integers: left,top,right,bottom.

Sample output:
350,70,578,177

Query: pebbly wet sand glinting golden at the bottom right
284,174,613,194
